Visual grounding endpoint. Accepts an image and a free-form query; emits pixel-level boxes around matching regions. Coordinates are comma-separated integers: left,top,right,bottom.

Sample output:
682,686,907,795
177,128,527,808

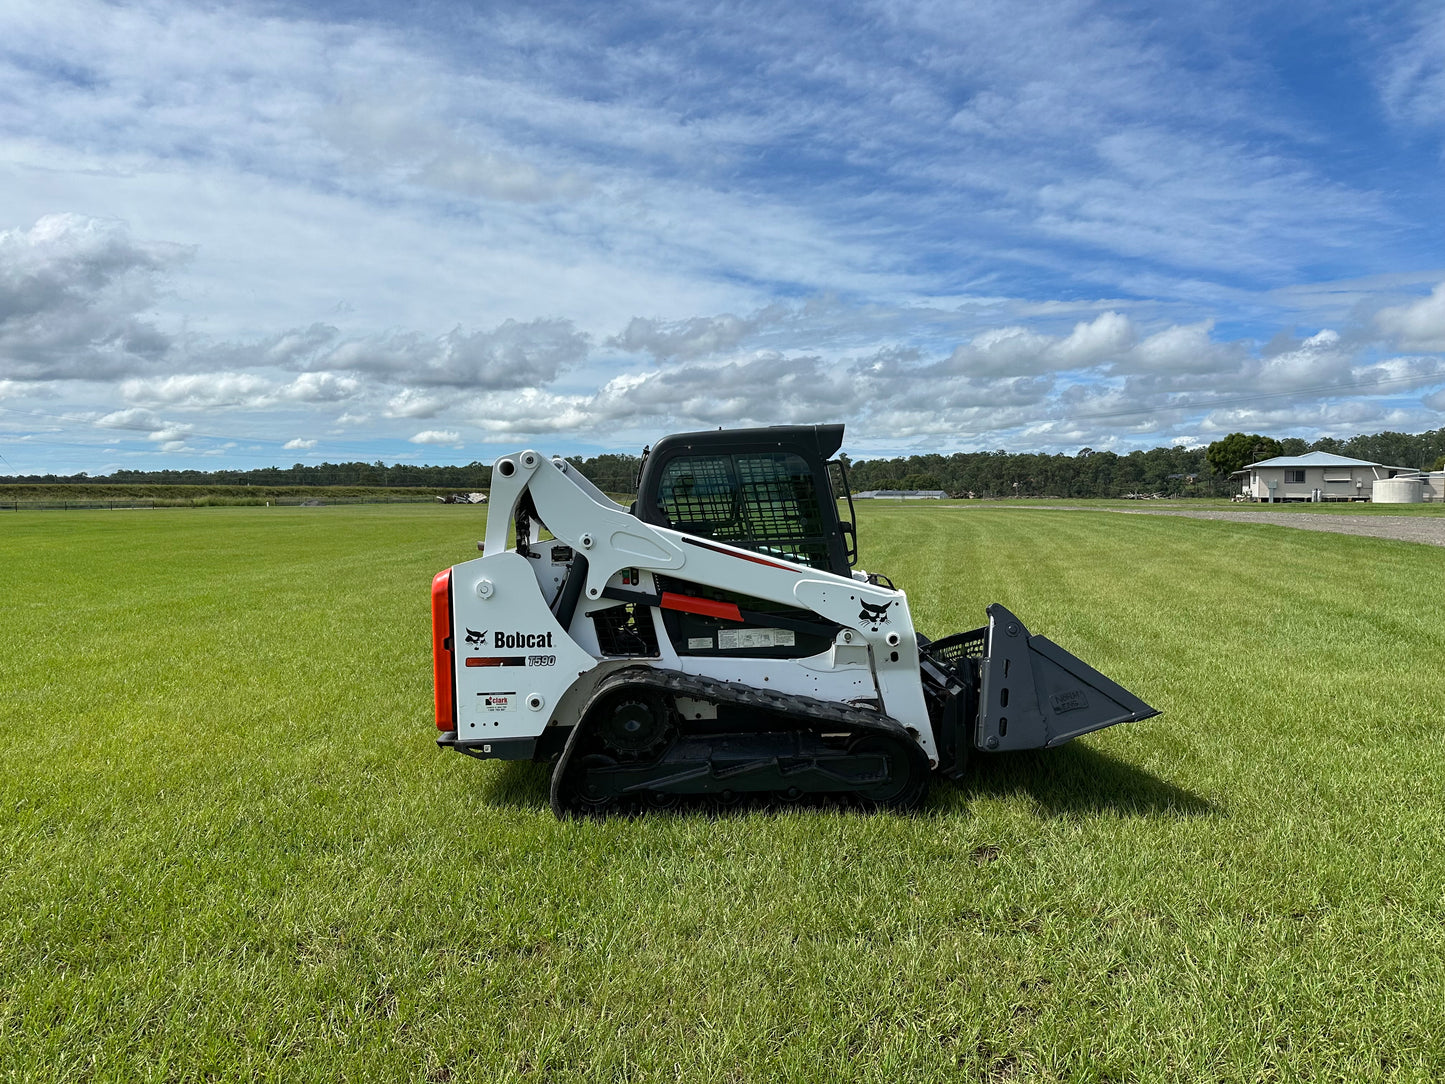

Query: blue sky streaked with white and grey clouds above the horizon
0,0,1445,474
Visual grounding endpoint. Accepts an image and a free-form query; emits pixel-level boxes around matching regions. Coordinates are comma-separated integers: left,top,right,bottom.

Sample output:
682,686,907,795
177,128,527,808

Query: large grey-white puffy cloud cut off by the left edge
0,214,189,380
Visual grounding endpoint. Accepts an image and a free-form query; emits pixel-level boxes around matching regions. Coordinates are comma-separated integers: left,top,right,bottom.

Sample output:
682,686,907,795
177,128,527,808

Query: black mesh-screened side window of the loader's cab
657,452,828,568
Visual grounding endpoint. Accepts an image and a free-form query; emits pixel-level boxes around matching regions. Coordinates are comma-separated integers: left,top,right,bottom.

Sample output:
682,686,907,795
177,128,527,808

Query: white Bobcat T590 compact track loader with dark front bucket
432,425,1157,817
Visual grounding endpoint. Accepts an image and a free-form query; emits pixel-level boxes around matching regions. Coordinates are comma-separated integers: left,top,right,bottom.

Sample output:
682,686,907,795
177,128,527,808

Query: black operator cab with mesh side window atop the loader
636,425,858,575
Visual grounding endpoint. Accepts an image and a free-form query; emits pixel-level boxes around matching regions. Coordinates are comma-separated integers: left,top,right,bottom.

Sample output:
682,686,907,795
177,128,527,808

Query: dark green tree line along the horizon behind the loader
11,428,1445,497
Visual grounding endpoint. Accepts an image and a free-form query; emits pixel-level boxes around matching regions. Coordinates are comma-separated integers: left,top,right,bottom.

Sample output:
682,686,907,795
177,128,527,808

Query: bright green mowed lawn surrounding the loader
0,506,1445,1084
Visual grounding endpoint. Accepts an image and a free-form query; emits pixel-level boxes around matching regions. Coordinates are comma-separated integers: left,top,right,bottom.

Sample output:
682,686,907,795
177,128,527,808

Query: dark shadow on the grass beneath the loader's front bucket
958,741,1221,817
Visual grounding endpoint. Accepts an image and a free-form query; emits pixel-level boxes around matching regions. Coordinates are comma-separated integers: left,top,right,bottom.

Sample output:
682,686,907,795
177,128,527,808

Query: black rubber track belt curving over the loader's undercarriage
551,666,929,817
